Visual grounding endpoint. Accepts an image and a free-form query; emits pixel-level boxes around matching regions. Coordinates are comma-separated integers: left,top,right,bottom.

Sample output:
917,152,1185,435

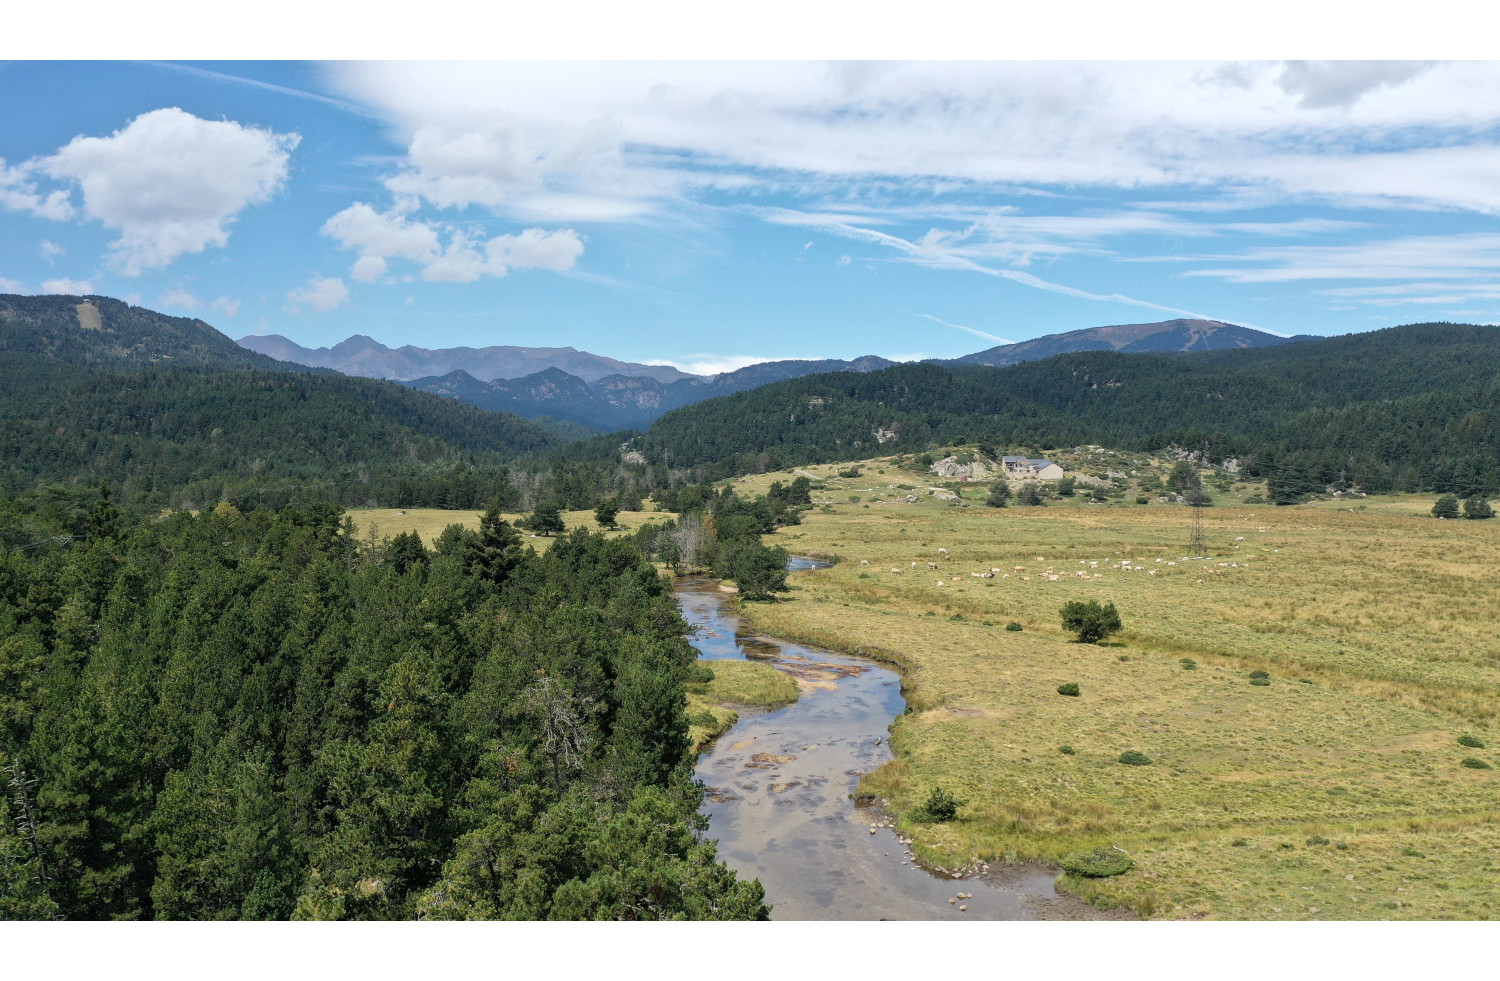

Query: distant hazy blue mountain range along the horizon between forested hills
239,320,1307,432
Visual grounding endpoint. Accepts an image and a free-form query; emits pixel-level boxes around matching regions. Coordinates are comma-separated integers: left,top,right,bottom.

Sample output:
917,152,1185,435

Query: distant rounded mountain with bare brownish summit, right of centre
932,320,1310,368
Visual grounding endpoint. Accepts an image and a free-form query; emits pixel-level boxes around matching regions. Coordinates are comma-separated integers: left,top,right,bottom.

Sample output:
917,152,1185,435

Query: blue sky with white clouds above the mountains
0,62,1500,371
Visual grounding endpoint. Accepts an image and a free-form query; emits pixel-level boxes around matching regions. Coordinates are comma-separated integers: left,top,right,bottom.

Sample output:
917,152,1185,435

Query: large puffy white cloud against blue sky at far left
36,108,300,276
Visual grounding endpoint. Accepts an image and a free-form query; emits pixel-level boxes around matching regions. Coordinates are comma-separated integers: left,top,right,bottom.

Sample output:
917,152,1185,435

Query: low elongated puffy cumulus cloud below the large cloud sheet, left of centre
323,200,584,282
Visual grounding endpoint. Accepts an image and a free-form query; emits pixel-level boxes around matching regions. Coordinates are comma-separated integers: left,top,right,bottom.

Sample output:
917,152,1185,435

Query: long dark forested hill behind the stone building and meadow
636,324,1500,492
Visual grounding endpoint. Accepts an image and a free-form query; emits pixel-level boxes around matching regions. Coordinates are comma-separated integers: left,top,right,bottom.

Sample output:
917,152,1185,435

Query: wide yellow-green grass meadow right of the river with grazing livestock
740,462,1500,920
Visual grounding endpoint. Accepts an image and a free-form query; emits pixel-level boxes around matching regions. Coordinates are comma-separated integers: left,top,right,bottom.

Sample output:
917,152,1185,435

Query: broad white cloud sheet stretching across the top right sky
329,62,1500,215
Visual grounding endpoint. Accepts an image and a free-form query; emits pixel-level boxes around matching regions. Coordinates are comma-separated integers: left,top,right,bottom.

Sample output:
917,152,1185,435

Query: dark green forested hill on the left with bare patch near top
0,296,560,507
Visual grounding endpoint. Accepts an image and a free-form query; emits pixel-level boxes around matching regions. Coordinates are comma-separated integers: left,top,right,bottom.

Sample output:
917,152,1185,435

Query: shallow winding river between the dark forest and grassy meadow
677,558,1058,920
